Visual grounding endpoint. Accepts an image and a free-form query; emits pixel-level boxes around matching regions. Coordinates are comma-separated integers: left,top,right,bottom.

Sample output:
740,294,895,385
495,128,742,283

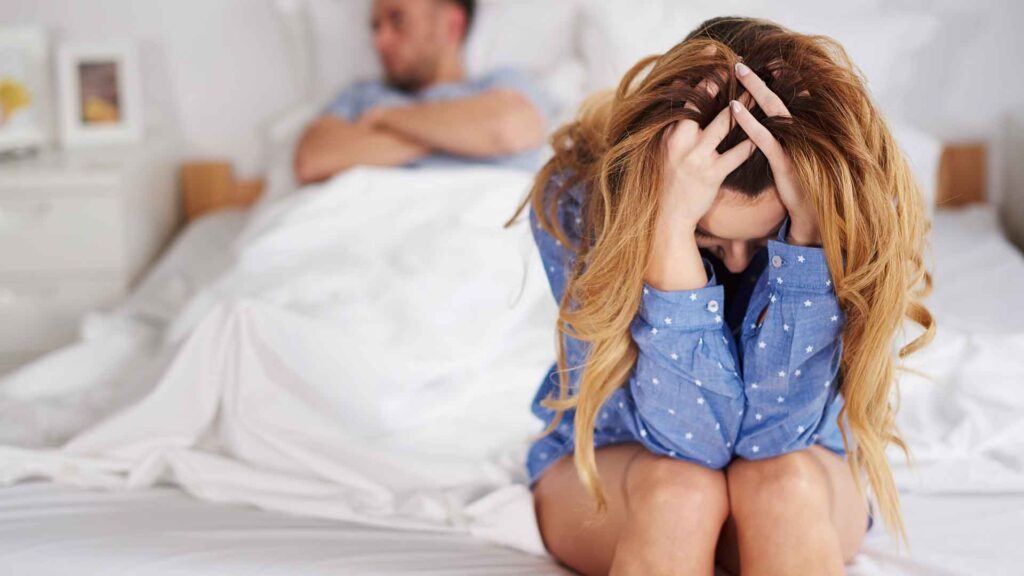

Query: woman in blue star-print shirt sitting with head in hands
509,17,934,576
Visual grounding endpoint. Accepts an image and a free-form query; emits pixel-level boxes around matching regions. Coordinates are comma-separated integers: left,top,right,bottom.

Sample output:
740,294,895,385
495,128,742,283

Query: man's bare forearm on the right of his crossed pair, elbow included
360,88,546,158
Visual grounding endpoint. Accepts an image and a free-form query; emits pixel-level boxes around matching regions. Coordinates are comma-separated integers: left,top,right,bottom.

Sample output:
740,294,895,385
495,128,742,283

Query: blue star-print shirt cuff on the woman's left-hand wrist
639,256,725,330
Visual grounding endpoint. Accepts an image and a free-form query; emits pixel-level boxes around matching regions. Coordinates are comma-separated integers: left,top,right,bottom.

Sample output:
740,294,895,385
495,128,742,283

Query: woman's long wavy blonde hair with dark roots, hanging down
506,17,935,545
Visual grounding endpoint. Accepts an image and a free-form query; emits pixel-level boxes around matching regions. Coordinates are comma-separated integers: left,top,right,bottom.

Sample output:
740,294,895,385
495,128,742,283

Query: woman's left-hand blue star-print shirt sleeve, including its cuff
530,171,743,468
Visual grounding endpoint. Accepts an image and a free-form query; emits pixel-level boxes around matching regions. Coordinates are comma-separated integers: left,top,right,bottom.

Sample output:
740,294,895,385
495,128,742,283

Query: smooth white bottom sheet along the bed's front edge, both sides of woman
0,473,1024,576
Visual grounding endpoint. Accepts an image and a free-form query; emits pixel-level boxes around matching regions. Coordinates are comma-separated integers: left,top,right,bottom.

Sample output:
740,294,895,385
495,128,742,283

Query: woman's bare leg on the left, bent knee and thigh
534,443,729,576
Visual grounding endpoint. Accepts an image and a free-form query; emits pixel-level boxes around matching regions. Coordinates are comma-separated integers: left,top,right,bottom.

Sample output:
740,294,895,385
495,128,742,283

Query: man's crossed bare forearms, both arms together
295,88,546,183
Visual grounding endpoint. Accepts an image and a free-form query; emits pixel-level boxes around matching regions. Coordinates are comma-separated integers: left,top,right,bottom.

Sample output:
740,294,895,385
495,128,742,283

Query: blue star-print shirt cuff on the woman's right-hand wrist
768,216,833,294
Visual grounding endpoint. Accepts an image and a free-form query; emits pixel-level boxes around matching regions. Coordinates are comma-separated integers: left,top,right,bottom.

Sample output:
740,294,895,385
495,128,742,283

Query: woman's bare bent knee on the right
717,445,867,576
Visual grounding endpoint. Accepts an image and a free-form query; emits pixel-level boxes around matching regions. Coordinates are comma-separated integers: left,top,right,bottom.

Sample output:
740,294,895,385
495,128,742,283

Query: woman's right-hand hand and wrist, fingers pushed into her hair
729,63,821,246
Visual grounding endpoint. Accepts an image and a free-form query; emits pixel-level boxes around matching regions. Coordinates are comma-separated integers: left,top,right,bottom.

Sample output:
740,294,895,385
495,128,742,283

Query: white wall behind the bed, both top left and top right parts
0,0,1024,246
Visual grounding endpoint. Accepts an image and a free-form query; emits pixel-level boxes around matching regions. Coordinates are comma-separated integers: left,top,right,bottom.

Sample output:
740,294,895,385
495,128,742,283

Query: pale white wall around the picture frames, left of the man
0,0,297,174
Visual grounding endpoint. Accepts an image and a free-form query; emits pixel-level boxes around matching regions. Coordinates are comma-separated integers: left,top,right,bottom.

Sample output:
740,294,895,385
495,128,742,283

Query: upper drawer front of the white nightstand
0,195,124,273
